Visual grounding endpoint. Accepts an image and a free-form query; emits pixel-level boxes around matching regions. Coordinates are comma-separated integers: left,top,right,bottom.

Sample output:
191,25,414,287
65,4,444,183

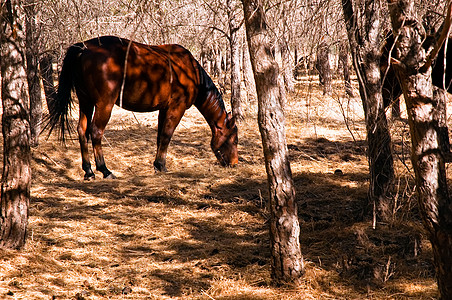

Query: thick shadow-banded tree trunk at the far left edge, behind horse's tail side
0,0,31,249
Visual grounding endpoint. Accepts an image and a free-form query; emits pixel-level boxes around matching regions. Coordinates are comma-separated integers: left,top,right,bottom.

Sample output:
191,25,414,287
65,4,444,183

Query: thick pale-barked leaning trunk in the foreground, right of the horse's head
242,0,304,284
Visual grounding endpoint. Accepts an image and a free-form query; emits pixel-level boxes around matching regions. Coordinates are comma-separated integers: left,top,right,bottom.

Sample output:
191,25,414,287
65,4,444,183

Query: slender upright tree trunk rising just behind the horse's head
227,0,243,122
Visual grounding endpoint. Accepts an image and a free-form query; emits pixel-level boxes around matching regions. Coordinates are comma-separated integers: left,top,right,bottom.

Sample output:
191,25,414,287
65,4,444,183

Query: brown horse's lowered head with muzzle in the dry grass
210,113,239,167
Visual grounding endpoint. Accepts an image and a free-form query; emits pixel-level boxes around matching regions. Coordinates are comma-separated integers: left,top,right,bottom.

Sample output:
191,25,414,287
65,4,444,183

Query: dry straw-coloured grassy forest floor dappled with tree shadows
0,79,442,300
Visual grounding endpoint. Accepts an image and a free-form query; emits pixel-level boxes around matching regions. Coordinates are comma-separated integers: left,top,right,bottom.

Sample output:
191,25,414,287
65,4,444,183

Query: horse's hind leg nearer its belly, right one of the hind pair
91,107,116,179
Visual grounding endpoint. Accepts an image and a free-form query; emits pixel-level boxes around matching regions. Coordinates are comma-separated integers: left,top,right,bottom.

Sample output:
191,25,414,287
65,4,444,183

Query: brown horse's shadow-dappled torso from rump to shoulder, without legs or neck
76,36,199,112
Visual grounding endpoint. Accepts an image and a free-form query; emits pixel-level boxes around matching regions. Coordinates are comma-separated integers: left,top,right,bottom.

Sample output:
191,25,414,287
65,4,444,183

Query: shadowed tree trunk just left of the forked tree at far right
342,0,394,227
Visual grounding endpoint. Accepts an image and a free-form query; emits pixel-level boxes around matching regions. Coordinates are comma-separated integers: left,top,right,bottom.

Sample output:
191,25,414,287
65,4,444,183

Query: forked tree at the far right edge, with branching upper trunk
388,0,452,299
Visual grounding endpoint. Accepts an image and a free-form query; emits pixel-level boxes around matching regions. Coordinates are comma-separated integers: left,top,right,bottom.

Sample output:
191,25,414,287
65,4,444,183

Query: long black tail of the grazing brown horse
44,43,84,143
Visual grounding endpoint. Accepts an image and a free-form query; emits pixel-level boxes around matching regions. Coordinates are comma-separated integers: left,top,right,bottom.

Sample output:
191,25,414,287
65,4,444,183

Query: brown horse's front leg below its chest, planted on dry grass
154,108,185,172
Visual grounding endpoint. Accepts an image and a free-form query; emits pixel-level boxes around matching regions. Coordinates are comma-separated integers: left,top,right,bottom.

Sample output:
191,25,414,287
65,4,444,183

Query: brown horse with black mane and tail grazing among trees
47,36,238,180
